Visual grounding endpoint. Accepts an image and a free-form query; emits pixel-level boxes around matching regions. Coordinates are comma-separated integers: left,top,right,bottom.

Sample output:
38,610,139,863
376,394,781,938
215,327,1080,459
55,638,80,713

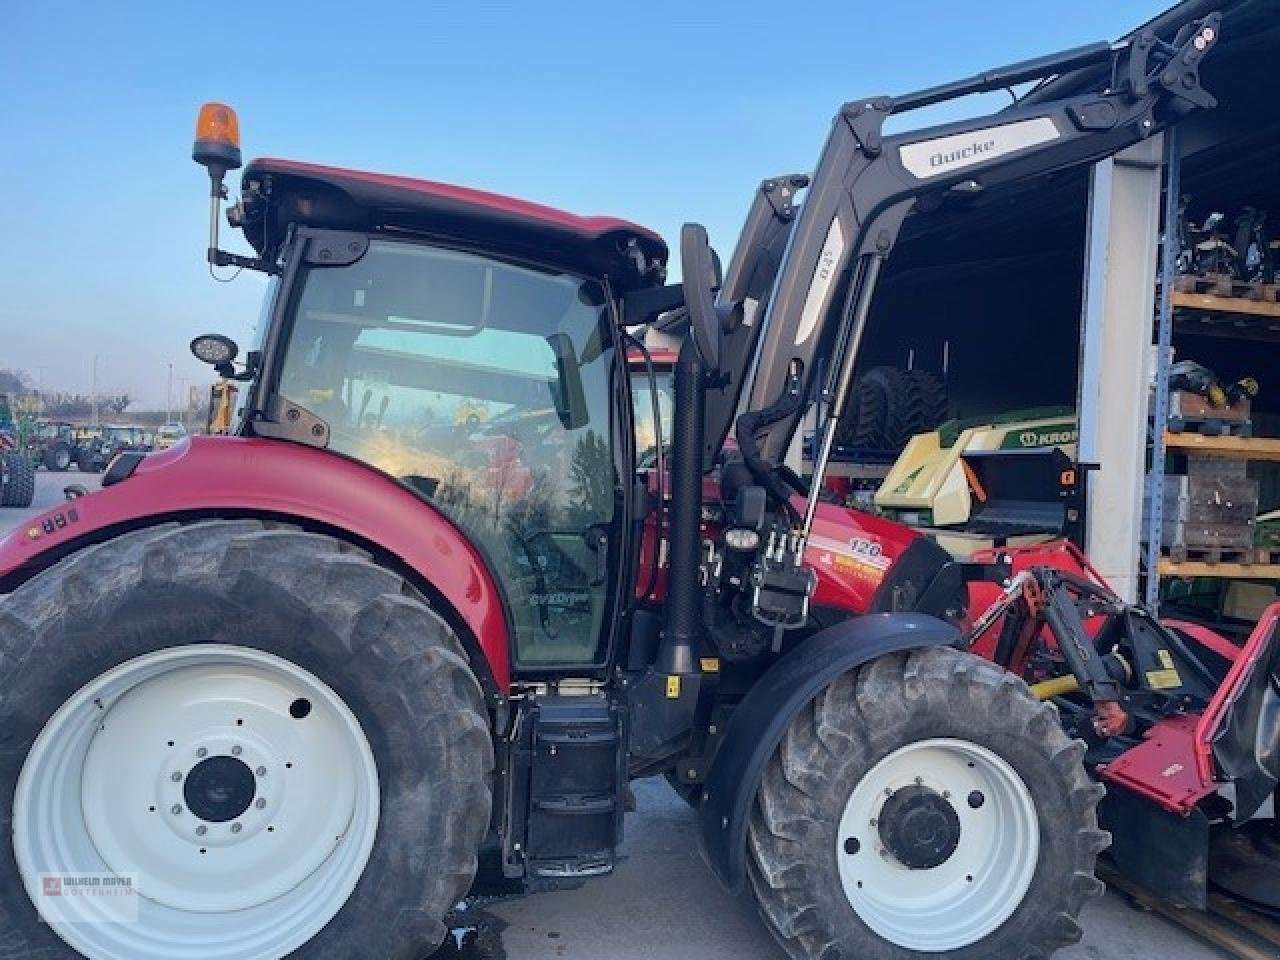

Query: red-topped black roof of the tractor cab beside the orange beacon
242,157,667,291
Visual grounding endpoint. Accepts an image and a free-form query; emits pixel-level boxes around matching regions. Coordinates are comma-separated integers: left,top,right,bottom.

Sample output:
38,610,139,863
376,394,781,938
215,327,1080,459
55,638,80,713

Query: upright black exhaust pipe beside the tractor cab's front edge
654,334,705,675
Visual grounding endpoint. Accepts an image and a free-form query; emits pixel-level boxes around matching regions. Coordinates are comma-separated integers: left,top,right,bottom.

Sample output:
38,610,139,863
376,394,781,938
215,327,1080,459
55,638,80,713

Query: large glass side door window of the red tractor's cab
278,239,621,666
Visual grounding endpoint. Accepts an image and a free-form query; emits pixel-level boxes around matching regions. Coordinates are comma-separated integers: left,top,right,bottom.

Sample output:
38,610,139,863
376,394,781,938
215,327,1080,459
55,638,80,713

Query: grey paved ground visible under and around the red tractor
0,470,1225,960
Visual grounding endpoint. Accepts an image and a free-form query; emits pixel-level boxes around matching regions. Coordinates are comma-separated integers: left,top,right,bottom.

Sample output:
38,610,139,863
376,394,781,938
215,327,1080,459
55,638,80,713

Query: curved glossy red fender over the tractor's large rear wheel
0,436,511,692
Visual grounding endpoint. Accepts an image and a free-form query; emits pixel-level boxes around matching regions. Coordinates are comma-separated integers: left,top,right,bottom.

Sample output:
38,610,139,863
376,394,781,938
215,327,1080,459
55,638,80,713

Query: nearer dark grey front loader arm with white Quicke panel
739,14,1221,532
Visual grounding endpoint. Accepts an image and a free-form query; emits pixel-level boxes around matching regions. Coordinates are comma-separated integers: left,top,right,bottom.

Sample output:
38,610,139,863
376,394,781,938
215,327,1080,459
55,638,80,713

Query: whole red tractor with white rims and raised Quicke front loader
0,15,1275,960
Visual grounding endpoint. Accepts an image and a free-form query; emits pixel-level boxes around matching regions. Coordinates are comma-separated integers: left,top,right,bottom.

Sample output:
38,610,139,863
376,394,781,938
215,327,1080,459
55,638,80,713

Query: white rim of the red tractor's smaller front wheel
836,739,1039,952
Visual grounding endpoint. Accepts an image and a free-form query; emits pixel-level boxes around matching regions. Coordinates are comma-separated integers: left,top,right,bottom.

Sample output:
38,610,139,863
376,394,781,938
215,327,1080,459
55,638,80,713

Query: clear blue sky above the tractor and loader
0,0,1167,408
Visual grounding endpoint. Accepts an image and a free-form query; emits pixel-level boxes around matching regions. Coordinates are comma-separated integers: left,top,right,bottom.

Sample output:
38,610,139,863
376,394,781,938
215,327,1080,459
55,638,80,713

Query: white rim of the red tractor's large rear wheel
13,645,379,960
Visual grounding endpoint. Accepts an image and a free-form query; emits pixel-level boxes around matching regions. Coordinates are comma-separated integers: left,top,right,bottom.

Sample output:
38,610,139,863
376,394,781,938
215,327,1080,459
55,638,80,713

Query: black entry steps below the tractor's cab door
503,694,627,879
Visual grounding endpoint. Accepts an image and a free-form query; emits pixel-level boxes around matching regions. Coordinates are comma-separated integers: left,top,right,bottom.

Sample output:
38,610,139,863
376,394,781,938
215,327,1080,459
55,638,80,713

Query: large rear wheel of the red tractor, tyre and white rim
0,521,493,960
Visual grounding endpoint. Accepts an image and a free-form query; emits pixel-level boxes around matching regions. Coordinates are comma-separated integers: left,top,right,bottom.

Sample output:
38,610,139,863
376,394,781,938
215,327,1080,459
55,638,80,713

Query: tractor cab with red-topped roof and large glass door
200,152,666,672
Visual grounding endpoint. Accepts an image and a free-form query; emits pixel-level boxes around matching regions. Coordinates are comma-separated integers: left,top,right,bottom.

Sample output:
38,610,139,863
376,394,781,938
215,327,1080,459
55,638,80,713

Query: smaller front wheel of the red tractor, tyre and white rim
748,649,1108,960
